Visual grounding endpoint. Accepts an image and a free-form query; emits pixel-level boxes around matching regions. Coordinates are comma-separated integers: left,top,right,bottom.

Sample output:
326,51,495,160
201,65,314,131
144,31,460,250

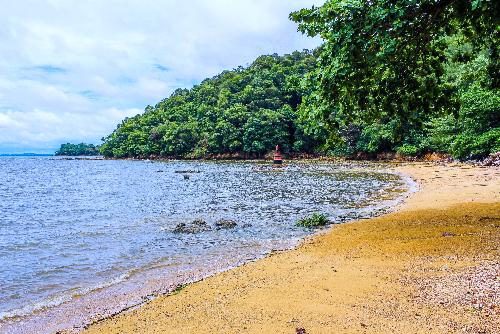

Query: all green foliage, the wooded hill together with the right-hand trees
101,0,500,159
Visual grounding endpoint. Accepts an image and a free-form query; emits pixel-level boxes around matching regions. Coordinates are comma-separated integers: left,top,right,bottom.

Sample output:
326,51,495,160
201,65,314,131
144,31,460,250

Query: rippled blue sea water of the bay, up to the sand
0,157,408,332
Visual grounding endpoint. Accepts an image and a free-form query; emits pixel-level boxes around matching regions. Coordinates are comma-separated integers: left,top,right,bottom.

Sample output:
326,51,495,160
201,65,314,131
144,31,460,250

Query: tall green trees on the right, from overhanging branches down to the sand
290,0,500,158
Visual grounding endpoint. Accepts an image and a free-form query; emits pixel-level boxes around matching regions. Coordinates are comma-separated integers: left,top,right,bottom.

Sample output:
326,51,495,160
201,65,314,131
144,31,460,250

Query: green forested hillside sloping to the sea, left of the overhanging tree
101,51,327,158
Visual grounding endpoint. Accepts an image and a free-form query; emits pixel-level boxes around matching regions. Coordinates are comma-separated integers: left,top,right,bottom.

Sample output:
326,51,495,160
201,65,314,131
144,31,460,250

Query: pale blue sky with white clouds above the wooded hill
0,0,323,153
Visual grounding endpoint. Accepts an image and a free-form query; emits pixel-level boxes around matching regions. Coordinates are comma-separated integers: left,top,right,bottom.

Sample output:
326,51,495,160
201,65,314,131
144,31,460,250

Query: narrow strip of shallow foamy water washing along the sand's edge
0,161,415,332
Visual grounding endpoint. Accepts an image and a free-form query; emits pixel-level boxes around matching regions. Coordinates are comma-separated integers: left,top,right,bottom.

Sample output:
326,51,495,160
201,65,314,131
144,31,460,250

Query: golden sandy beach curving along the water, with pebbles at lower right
87,163,500,333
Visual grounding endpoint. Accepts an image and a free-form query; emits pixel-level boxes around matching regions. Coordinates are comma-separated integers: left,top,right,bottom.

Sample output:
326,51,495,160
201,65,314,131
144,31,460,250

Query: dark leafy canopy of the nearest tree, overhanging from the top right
290,0,500,128
